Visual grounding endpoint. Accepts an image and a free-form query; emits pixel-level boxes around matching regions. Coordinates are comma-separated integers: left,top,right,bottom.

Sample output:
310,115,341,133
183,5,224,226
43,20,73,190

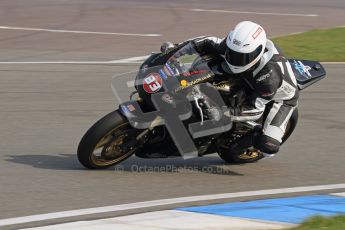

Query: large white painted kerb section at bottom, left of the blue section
20,210,295,230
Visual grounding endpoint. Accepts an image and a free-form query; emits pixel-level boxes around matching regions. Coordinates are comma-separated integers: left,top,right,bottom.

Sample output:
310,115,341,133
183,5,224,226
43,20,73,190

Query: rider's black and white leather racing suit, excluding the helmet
192,36,299,154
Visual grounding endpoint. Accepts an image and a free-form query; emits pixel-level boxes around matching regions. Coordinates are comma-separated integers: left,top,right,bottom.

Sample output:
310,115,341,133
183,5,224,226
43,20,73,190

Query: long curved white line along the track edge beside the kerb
0,183,345,226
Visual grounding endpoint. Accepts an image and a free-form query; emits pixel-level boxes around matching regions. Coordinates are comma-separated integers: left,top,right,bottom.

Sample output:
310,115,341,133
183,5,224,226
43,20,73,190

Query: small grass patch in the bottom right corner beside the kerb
289,215,345,230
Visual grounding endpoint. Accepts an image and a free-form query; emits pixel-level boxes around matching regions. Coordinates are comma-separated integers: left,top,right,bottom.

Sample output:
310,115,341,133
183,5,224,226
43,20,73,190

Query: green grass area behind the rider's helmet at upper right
272,28,345,61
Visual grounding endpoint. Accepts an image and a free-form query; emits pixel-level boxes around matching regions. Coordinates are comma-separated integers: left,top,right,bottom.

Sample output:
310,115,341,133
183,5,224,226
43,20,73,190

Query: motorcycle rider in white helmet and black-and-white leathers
163,21,299,156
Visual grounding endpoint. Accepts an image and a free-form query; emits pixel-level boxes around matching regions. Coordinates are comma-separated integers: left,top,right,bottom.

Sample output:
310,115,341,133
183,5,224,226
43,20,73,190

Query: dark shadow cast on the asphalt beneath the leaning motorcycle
5,154,243,176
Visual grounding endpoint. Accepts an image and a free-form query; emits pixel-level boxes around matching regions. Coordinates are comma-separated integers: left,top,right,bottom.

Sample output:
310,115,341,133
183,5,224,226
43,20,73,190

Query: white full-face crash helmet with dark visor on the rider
225,21,267,73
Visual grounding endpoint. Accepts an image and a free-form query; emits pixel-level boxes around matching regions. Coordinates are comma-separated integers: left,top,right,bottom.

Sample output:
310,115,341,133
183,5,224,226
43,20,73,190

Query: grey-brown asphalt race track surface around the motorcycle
0,0,345,227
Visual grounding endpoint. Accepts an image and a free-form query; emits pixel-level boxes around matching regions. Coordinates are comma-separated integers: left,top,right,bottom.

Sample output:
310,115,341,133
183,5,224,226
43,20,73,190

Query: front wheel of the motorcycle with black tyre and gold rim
77,110,139,169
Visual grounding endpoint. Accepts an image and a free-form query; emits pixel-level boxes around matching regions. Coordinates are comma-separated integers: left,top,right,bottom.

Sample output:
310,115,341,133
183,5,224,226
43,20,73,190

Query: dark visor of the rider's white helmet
225,45,262,67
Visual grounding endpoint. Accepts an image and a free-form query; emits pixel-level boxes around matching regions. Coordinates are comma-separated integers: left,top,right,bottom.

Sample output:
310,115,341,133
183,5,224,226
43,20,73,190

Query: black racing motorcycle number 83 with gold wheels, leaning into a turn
77,41,326,169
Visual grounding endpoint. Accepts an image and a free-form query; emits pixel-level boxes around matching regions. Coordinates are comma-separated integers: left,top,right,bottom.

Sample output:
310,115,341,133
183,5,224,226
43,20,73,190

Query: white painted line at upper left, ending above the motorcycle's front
0,26,162,37
